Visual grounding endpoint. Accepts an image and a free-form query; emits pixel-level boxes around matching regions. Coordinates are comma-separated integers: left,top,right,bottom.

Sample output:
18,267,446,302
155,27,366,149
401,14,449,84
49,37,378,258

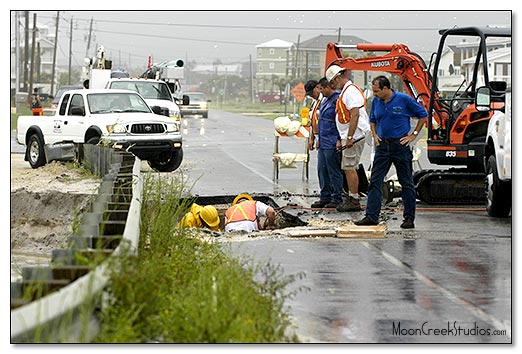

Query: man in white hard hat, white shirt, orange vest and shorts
326,65,370,211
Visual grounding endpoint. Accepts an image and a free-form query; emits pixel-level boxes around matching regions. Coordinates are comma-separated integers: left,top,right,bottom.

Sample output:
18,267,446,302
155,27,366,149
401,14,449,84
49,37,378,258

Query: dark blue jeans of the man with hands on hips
366,140,417,221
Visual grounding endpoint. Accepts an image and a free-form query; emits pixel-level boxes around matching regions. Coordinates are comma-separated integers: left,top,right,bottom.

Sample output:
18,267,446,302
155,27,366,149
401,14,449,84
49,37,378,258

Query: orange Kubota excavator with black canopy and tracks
325,27,511,204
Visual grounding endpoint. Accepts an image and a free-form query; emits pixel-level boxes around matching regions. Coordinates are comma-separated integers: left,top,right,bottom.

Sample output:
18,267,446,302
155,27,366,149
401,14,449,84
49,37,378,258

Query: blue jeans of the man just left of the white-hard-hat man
317,149,344,204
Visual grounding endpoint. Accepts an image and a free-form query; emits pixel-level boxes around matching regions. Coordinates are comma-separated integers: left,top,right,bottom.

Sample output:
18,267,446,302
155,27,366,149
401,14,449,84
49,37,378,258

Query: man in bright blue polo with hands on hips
354,76,428,229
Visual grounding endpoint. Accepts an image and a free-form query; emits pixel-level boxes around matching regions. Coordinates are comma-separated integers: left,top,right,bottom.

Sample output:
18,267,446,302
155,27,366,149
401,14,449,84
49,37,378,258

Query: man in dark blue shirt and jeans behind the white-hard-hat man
312,78,343,208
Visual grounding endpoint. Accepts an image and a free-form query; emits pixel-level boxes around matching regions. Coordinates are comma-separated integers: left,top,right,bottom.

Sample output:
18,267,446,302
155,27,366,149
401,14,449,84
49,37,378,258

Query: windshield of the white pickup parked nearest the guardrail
87,92,151,114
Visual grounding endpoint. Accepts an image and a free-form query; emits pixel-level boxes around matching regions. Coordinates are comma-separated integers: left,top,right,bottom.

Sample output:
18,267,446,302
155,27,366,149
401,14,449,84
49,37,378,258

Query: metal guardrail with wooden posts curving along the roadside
11,145,143,343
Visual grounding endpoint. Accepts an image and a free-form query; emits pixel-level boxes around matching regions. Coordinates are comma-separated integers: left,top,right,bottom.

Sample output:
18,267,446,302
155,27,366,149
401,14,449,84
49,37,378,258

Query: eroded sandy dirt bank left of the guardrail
10,154,101,276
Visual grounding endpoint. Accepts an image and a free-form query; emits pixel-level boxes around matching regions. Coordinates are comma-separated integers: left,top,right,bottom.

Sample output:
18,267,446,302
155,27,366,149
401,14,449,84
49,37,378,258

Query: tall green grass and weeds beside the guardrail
96,175,299,343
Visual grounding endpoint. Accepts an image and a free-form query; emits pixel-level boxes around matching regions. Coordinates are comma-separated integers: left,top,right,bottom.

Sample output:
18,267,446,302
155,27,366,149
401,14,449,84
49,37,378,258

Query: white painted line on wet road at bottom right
362,242,511,339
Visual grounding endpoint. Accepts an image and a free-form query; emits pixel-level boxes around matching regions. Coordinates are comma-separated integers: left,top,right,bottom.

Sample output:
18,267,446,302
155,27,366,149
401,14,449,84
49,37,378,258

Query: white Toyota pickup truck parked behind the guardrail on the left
17,89,183,172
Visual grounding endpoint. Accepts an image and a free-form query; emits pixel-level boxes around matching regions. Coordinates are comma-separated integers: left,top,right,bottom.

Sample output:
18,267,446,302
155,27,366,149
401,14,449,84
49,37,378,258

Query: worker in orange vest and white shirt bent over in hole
225,194,276,231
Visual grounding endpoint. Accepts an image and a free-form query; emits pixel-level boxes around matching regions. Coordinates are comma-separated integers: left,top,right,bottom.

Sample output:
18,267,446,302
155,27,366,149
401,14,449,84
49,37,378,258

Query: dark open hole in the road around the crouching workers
184,195,307,230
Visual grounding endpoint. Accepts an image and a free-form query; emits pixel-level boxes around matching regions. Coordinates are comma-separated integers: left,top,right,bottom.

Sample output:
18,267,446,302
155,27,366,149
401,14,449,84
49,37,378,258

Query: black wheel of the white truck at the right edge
486,156,511,217
